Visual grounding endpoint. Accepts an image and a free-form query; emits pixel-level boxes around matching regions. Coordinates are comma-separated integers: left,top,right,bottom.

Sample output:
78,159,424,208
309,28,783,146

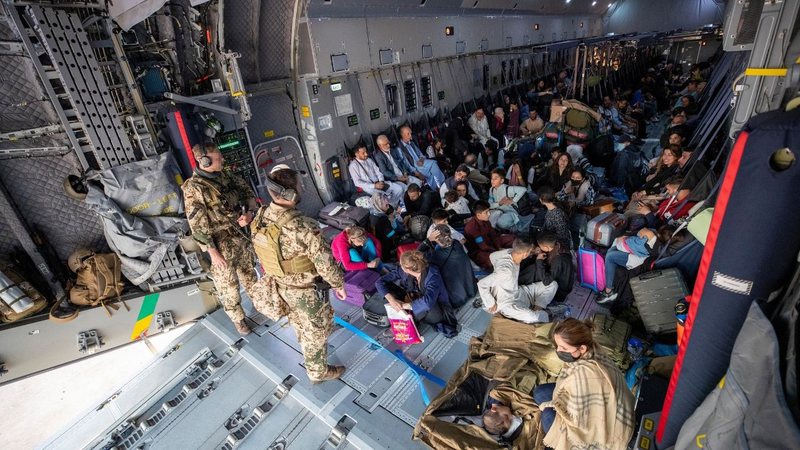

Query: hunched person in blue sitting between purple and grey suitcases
597,228,658,305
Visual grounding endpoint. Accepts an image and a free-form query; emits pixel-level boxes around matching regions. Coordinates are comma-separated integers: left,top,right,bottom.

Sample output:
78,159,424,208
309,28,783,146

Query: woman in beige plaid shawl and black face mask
533,318,635,450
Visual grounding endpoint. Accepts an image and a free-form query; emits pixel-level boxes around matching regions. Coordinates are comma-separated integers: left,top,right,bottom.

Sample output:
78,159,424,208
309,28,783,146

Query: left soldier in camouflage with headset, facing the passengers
181,144,258,335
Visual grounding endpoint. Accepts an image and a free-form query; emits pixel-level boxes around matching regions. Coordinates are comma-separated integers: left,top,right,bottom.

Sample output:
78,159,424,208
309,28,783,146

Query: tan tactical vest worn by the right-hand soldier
253,207,315,277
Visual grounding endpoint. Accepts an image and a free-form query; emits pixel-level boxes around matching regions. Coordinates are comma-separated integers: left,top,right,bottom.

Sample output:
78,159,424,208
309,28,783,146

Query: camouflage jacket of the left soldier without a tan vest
181,170,256,248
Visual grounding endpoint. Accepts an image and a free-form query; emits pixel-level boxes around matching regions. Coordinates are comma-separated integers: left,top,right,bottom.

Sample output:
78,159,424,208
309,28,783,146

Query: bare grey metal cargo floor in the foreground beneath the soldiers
39,276,598,450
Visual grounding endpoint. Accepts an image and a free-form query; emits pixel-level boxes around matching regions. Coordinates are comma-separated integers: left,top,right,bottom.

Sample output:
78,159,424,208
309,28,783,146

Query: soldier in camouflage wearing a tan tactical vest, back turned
251,164,345,382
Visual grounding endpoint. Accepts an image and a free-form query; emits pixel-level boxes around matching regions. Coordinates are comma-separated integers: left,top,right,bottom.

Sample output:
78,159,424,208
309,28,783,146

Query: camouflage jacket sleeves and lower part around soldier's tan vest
250,203,344,289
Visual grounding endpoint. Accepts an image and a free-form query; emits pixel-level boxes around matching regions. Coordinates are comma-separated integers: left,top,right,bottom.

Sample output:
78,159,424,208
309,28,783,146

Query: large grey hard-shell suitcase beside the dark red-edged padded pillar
630,268,689,334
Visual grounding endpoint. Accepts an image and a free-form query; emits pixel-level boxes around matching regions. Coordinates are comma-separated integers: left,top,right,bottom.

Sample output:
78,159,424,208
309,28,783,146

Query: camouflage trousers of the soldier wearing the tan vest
278,286,333,380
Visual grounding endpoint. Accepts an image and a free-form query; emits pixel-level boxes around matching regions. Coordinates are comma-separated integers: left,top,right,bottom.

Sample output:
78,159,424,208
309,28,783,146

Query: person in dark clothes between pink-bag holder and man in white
418,225,478,308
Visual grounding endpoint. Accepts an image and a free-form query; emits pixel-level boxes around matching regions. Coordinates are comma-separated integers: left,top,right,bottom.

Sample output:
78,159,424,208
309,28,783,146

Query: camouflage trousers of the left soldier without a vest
211,235,256,323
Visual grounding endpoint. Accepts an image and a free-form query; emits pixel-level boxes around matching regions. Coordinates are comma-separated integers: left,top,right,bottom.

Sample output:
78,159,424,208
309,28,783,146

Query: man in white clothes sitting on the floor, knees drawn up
478,239,558,323
